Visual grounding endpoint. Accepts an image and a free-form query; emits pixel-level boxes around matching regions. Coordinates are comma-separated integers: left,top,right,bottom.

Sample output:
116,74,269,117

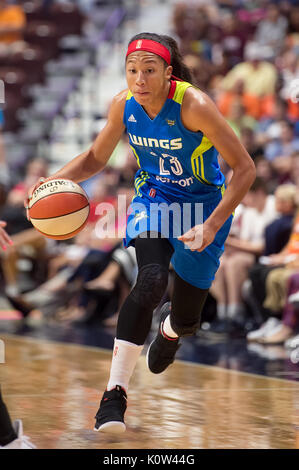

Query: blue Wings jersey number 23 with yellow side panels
124,81,225,201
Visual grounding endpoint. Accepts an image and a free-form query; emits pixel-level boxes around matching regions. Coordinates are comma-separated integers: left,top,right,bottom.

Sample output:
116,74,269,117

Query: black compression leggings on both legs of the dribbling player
116,237,208,345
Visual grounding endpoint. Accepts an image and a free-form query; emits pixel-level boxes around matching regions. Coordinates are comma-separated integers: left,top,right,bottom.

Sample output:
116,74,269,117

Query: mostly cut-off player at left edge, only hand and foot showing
0,221,35,449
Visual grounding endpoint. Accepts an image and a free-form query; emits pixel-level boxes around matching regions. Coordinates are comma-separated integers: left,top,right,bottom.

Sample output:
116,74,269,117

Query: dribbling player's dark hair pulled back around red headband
128,33,192,83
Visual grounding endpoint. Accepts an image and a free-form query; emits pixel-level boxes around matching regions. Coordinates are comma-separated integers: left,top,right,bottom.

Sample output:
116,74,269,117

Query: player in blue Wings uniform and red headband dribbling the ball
26,33,255,433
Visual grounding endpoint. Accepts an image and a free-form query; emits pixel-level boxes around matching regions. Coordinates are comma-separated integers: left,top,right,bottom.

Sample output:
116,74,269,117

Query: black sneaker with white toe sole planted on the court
94,385,127,434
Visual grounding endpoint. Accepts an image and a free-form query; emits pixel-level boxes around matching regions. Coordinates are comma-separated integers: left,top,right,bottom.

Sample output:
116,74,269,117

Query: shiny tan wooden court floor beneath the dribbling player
0,334,299,449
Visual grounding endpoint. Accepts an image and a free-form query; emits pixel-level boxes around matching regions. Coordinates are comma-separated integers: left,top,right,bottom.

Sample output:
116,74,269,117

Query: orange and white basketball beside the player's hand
29,179,89,240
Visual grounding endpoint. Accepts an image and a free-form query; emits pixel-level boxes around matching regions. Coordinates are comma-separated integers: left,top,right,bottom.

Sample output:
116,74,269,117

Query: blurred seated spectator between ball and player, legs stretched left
9,182,136,326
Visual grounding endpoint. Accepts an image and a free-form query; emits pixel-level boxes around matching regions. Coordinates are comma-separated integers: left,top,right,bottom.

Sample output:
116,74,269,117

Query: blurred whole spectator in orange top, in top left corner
0,0,26,55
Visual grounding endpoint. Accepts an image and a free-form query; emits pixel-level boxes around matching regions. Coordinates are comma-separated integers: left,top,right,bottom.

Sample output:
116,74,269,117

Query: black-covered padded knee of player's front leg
131,264,168,310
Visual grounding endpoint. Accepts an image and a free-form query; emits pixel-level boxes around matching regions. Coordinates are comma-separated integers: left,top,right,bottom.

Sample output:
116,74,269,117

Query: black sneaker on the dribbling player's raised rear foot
146,302,181,374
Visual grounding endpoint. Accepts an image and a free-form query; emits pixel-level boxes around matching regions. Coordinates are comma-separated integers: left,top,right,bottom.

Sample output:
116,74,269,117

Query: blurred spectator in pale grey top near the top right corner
254,3,288,59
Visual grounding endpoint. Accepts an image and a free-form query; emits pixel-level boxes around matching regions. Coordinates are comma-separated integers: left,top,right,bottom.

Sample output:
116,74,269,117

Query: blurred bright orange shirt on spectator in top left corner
0,0,26,44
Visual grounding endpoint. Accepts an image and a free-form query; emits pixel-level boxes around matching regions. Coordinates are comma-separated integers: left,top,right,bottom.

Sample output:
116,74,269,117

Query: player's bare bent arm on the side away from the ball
182,88,256,250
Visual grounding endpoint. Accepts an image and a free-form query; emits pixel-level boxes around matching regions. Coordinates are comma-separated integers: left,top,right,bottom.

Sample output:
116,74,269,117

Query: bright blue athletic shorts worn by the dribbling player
124,185,232,289
